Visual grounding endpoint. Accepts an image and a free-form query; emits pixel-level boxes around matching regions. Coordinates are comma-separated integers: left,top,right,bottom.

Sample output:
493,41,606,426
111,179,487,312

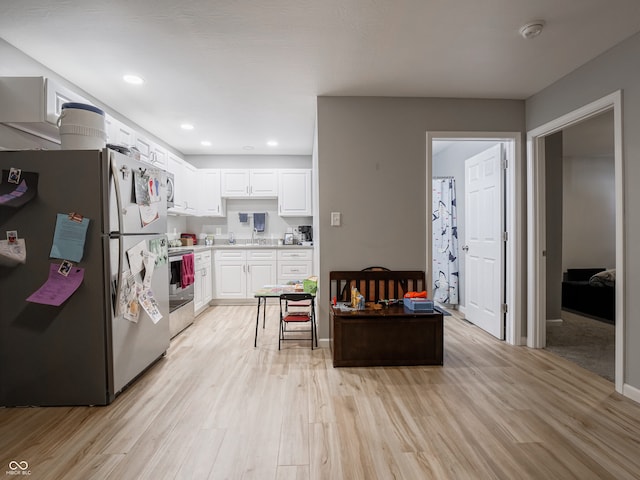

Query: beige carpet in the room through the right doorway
547,311,616,382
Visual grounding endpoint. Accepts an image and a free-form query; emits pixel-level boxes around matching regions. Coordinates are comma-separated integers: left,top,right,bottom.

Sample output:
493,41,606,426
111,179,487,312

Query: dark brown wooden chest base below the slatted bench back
329,305,443,367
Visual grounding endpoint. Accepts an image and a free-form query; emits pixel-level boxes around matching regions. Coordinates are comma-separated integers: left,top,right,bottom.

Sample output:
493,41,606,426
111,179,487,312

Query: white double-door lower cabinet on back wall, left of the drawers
214,249,277,300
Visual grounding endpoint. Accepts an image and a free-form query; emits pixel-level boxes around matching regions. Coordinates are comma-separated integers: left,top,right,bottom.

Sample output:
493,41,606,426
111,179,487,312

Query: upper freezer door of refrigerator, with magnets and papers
109,150,167,234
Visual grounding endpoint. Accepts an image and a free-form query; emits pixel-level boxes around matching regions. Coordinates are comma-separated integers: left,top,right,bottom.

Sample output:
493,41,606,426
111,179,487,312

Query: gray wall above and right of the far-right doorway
526,30,640,389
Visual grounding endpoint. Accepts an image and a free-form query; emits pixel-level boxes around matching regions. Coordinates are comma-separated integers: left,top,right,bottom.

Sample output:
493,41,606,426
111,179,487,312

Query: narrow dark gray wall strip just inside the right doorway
544,132,563,320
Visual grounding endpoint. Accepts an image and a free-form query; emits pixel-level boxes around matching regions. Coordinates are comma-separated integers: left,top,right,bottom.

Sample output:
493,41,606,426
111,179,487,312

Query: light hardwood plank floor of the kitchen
0,306,640,480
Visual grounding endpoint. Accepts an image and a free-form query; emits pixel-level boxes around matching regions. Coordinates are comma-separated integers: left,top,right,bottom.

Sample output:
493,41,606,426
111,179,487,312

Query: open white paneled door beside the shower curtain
463,144,504,339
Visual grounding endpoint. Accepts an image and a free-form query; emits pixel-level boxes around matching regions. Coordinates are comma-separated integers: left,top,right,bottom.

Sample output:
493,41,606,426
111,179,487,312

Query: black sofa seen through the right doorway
562,268,616,323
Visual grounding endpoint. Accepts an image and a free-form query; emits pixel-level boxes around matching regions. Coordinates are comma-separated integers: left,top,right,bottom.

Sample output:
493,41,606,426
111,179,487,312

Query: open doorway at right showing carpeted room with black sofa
545,110,616,382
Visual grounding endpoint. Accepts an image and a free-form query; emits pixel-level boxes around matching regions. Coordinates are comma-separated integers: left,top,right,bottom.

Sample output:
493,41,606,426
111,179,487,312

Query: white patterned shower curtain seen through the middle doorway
432,178,458,305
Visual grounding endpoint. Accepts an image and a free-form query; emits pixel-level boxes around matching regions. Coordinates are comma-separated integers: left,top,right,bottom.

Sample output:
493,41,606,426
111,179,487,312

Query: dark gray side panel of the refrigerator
0,150,108,406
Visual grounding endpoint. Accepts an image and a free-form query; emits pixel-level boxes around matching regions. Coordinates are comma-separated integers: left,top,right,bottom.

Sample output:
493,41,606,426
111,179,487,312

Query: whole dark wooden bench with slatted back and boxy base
329,270,443,367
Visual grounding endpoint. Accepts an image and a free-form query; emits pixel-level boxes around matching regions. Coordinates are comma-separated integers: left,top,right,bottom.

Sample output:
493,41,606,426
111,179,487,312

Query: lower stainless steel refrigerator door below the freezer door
109,235,169,394
